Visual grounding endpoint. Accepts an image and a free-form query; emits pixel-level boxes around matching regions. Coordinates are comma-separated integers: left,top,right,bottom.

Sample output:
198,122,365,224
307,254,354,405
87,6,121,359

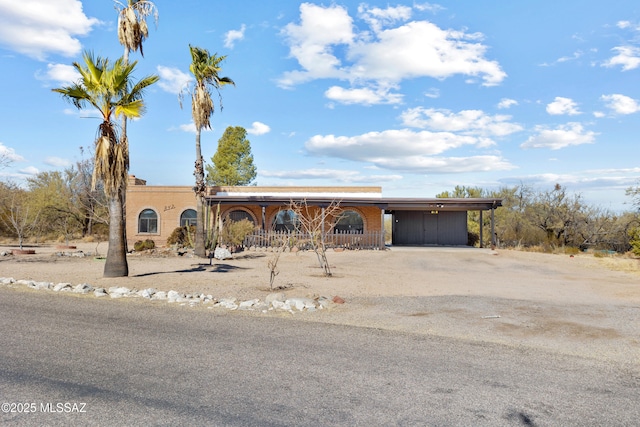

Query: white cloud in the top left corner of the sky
0,0,100,60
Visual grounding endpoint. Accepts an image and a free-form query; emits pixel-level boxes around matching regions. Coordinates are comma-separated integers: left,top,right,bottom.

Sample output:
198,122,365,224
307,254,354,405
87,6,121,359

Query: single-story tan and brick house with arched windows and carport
126,176,502,251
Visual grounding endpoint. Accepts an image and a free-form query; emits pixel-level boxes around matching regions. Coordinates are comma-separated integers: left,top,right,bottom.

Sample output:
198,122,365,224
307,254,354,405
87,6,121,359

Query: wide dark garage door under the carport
392,211,468,246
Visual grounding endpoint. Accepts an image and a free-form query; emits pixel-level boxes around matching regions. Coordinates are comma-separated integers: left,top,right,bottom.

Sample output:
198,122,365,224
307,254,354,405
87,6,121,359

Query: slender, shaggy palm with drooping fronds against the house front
181,45,235,257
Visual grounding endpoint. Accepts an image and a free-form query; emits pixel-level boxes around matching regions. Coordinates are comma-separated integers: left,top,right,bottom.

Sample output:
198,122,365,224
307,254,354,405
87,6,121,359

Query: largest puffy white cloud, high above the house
278,3,506,98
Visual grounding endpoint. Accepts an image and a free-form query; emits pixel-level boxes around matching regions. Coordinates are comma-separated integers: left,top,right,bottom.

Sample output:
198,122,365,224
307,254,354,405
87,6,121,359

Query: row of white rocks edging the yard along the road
0,277,335,314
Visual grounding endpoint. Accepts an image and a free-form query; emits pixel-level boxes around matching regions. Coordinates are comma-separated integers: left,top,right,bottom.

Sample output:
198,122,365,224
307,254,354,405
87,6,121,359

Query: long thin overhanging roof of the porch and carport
205,195,502,212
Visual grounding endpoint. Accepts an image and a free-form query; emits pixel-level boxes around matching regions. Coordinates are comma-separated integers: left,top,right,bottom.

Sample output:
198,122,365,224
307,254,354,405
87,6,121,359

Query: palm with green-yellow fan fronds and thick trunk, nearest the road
52,52,159,277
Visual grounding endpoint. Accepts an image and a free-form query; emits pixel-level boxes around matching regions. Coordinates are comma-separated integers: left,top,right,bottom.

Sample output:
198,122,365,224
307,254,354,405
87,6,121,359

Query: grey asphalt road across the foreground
0,288,640,426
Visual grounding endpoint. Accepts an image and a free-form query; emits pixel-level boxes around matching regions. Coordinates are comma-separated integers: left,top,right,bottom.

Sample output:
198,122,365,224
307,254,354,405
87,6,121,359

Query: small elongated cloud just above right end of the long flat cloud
400,107,522,136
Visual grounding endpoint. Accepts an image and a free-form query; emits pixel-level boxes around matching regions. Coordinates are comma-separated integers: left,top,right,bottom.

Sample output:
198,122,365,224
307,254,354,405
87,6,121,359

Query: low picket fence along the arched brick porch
242,231,385,250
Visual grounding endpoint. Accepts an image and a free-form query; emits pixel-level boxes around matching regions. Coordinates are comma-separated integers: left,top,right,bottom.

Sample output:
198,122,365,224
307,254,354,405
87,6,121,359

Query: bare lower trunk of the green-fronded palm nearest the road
103,189,129,277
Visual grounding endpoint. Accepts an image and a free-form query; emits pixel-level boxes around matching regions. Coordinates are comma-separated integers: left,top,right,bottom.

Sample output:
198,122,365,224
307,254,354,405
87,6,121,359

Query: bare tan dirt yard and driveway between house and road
0,243,640,371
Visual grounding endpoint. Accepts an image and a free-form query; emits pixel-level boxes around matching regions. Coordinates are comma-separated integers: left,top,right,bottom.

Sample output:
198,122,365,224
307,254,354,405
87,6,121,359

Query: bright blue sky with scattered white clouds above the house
0,0,640,211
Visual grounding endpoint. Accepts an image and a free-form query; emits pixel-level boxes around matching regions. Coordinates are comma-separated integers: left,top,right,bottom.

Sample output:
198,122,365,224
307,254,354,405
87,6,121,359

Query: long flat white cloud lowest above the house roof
305,129,512,173
